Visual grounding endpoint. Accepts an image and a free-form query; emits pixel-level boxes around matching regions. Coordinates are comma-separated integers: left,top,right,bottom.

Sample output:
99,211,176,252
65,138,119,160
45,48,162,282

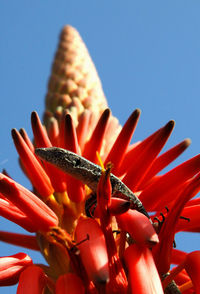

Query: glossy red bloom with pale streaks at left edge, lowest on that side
0,253,32,286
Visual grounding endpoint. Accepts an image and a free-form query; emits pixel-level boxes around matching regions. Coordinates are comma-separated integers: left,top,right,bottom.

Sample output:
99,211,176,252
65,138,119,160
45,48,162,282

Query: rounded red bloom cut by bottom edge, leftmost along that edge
17,265,47,294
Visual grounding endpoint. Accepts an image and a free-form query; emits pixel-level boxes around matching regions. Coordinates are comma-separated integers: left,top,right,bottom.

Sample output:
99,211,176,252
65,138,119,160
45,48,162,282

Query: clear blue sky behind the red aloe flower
0,0,200,293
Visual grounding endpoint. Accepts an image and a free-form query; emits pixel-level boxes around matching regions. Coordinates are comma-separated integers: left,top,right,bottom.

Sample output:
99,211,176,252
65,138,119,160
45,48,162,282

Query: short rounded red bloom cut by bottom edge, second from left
55,273,85,294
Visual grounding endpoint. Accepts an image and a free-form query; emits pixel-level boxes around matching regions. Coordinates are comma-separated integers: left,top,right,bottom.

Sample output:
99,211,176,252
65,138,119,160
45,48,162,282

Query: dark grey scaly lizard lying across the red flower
35,147,149,218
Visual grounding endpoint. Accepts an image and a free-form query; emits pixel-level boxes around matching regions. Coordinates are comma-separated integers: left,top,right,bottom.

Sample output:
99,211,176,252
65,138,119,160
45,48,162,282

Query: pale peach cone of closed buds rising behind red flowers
45,26,107,124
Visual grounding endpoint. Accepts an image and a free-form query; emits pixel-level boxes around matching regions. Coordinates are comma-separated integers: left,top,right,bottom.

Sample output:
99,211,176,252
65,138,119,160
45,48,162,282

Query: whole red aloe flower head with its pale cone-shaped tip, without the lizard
0,26,200,294
